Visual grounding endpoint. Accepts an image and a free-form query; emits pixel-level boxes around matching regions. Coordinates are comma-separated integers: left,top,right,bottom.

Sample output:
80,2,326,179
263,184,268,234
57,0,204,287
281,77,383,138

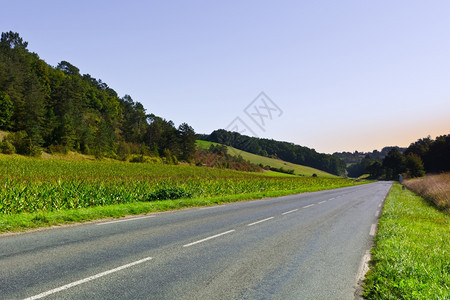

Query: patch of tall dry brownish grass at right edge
403,173,450,213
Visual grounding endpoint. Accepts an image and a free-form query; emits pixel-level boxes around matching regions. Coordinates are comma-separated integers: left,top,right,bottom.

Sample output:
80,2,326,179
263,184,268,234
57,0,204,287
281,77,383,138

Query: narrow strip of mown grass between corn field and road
0,186,358,233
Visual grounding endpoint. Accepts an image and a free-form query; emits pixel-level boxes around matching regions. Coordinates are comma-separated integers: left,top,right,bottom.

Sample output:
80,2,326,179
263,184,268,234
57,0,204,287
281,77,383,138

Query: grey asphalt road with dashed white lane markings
0,182,391,299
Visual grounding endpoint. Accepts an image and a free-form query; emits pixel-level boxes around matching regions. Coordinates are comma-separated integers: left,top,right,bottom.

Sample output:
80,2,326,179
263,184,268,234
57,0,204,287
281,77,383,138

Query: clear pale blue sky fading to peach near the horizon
0,0,450,153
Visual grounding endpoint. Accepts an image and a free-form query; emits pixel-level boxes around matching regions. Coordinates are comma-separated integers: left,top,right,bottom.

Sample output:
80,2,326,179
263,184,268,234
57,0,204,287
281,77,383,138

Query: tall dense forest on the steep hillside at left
0,32,196,162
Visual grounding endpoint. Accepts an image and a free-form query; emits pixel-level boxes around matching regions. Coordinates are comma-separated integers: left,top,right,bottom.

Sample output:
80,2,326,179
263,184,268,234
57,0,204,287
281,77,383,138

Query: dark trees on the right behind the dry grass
348,134,450,180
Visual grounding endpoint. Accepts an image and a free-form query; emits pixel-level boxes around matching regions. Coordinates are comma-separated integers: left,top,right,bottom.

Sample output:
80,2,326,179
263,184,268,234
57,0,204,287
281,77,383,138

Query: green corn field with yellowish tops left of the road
0,156,353,215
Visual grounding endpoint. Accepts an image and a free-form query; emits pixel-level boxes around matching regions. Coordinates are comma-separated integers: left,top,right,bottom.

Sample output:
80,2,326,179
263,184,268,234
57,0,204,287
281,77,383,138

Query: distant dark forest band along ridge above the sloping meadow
197,129,345,175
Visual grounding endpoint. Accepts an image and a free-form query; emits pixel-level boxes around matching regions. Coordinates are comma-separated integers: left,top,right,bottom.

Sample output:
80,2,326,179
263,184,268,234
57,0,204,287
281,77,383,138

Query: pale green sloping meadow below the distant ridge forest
197,140,338,178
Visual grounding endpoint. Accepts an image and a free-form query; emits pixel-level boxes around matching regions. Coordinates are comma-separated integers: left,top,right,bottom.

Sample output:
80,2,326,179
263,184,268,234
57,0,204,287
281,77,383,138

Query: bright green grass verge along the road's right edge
364,184,450,299
